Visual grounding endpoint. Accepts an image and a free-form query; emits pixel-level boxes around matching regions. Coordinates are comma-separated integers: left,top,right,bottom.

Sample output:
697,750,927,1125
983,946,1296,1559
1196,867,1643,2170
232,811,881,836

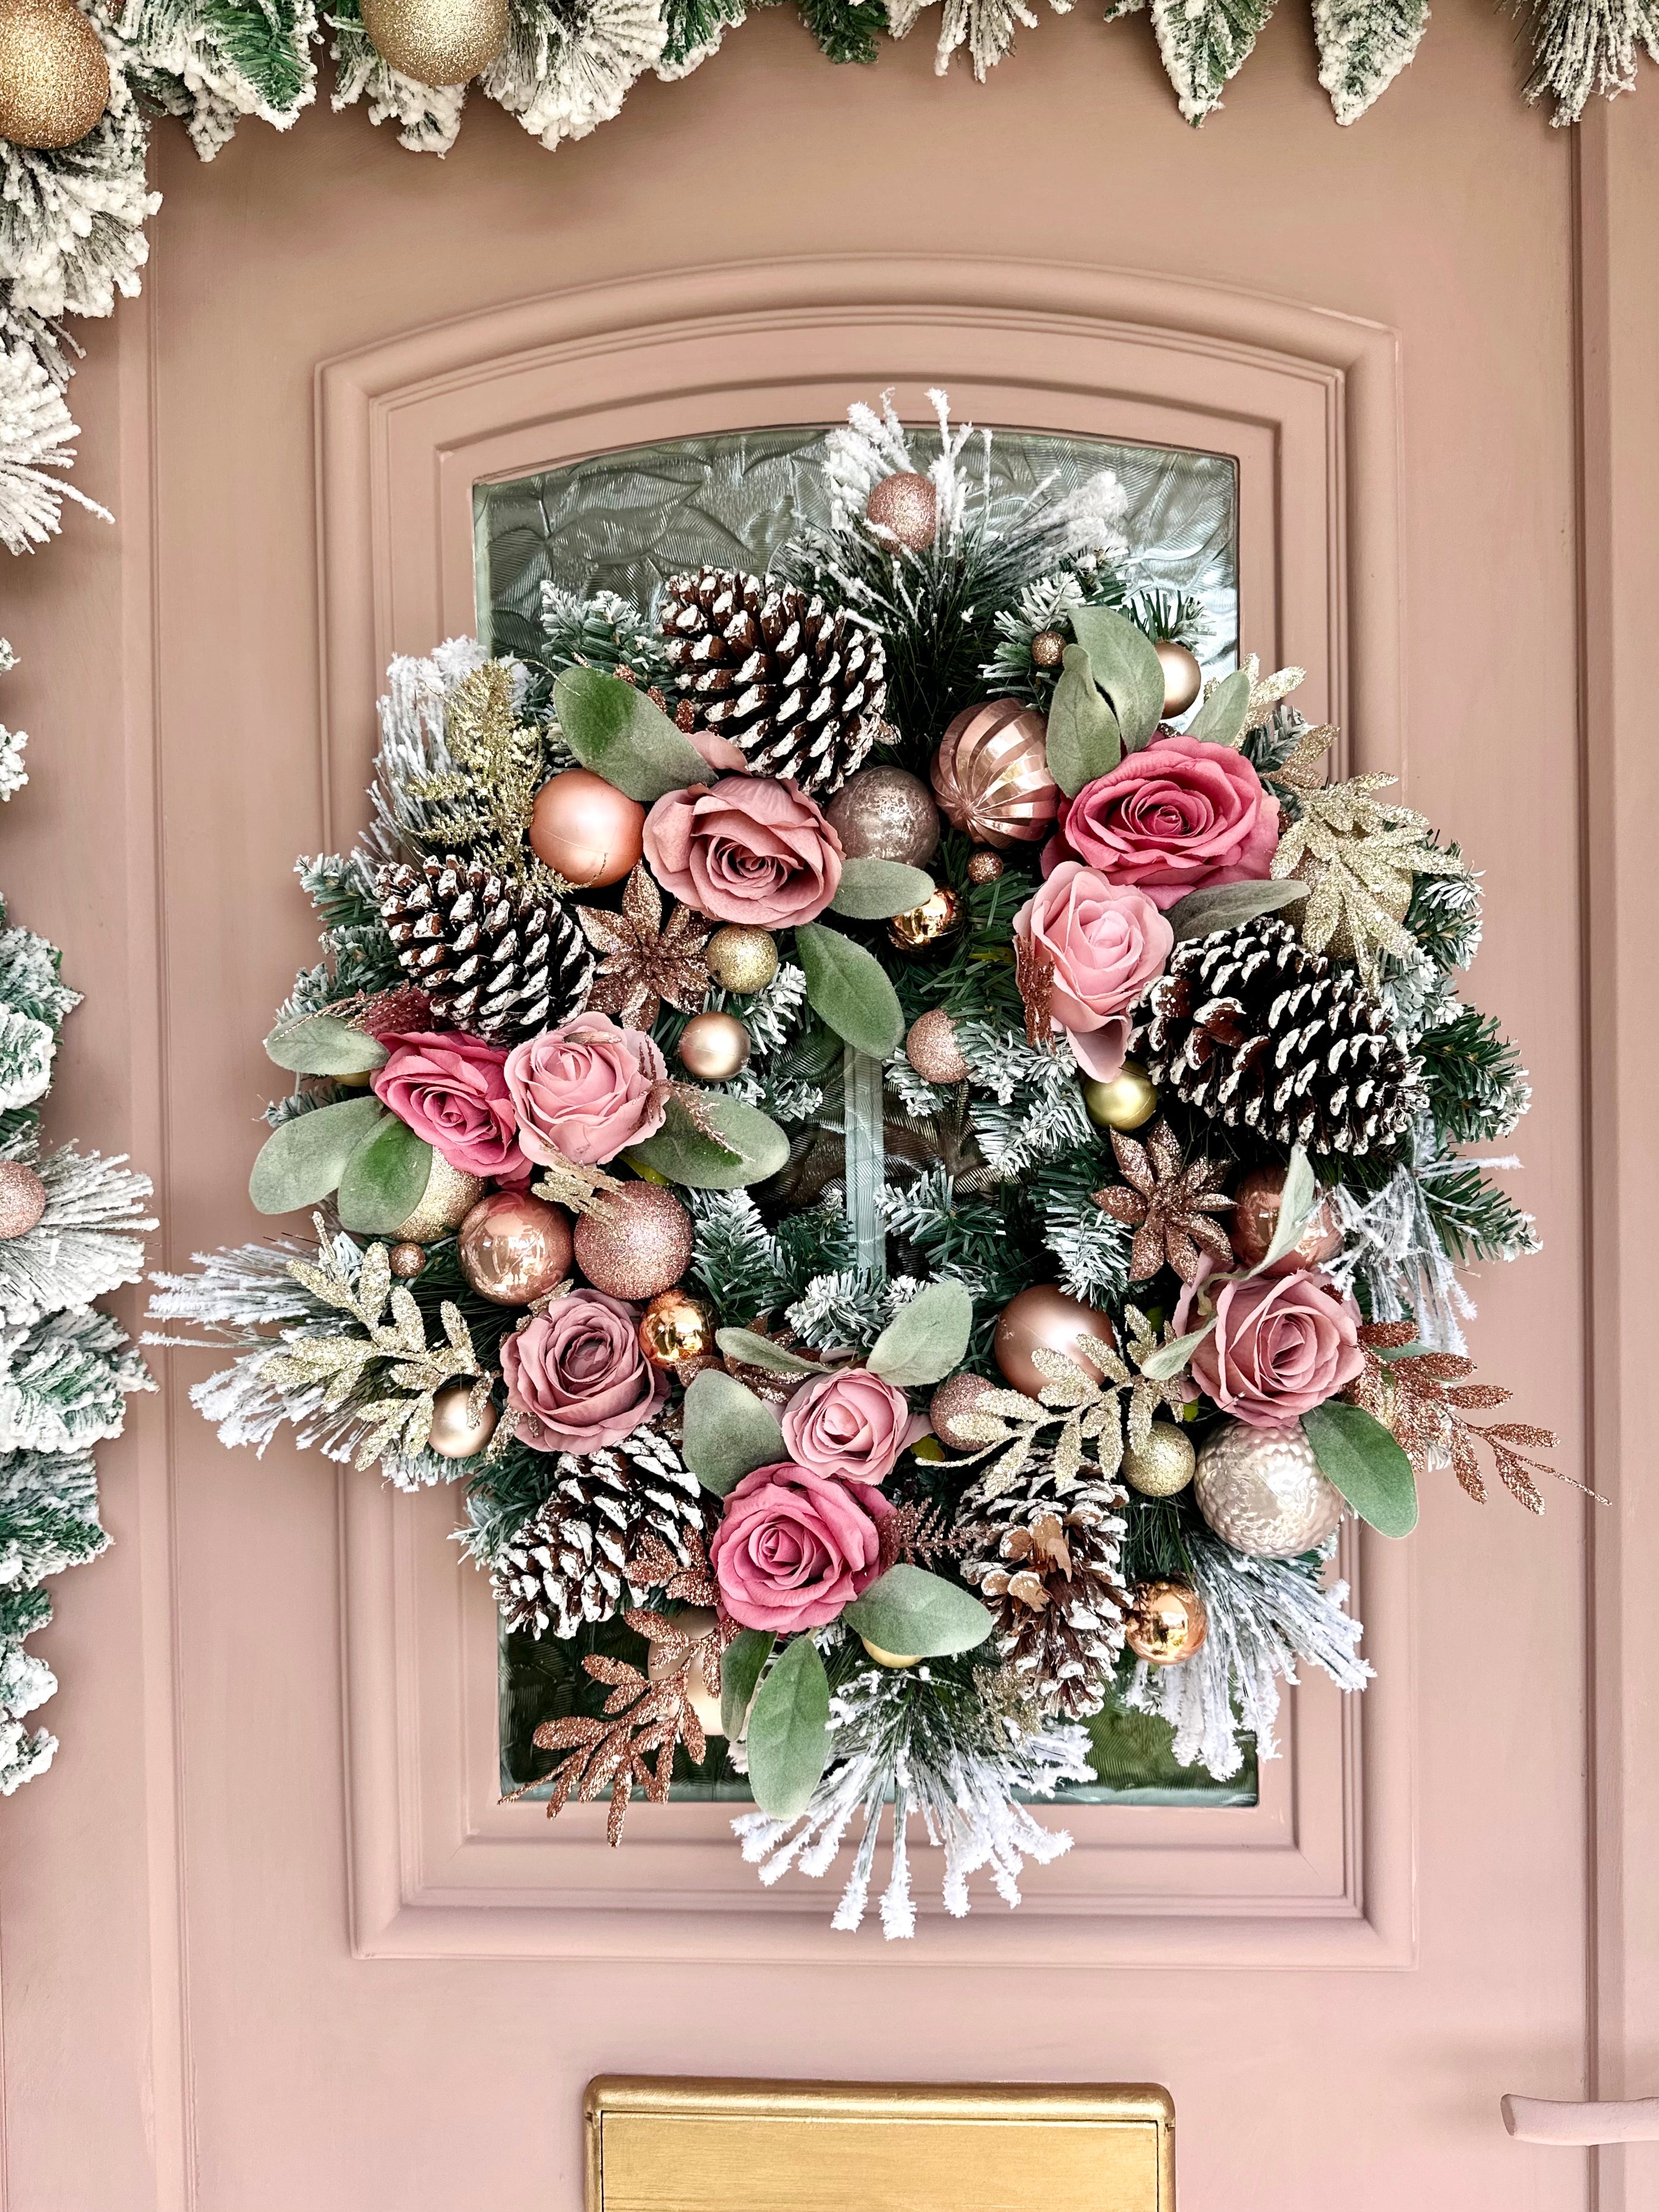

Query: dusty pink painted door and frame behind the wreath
0,7,1659,2212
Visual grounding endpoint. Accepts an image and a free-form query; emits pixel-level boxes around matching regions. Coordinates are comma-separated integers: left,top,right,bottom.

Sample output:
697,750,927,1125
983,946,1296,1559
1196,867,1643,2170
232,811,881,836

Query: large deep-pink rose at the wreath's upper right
1044,736,1279,907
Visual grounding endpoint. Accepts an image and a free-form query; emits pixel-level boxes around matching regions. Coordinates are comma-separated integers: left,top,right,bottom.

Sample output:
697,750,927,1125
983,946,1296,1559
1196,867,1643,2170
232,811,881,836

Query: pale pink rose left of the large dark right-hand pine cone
1013,861,1175,1082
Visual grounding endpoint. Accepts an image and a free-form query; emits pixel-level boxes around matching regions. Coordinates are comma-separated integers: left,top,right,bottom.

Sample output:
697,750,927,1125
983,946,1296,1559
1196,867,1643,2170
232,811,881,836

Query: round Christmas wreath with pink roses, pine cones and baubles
155,398,1553,1936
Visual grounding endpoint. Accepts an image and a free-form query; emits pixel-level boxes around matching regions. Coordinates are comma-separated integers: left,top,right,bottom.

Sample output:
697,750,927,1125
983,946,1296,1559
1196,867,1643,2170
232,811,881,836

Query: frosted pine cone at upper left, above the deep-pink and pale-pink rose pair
374,854,593,1044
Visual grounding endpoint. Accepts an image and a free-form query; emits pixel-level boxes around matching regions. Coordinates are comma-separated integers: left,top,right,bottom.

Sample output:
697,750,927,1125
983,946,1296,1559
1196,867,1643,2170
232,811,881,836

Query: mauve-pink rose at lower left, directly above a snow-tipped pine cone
502,1290,668,1451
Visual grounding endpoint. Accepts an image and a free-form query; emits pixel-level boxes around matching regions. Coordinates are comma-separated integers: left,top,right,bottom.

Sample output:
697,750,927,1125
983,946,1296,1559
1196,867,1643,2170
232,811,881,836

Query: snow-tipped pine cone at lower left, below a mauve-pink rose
489,1427,704,1637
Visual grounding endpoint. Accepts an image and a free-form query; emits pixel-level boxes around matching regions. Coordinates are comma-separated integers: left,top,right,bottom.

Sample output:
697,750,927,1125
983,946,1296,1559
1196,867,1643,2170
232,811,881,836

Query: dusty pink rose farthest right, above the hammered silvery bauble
1193,1268,1365,1429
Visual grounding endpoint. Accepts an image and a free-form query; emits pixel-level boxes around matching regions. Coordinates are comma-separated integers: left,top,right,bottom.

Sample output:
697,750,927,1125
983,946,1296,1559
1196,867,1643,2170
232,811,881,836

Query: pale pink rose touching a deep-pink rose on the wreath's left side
506,1013,668,1168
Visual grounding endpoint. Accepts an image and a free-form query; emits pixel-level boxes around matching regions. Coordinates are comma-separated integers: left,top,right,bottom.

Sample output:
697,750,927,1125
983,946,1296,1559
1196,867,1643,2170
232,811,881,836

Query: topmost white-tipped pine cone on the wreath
657,569,887,799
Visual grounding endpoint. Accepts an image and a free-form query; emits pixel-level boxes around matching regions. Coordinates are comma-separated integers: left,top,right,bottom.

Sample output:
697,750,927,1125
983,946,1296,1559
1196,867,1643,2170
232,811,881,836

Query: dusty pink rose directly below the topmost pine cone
646,776,843,929
